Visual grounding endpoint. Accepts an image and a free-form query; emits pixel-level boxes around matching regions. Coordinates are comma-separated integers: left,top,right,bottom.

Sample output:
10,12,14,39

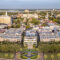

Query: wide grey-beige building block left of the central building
0,28,23,42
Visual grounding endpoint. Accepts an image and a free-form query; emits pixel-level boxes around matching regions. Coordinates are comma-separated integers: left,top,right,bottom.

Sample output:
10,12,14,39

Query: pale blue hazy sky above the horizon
0,0,60,9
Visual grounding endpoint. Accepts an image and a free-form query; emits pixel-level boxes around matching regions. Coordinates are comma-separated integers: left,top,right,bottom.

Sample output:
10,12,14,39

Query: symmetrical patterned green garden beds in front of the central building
20,49,38,59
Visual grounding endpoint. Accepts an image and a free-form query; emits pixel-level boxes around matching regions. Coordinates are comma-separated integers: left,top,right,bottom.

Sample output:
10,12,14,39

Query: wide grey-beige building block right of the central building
39,29,60,42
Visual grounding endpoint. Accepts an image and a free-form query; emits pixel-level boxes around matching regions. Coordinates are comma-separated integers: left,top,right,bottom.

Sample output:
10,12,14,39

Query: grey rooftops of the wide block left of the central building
0,28,23,39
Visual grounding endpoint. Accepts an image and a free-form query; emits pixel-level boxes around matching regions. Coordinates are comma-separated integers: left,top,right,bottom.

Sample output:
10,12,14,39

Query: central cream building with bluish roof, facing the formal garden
24,30,37,49
